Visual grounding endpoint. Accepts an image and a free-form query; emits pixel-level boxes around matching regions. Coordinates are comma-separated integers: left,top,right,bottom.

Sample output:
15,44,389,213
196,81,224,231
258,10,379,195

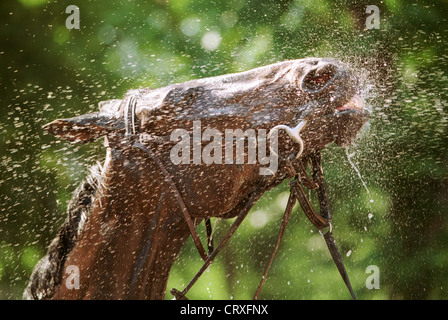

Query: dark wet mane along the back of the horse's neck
23,163,102,300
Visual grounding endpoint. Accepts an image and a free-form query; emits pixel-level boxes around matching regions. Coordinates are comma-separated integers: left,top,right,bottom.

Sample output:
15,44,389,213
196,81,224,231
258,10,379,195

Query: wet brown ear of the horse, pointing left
43,112,123,143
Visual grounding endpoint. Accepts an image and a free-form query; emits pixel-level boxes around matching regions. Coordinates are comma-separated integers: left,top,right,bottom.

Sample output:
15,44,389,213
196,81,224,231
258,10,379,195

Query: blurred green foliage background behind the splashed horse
0,0,448,299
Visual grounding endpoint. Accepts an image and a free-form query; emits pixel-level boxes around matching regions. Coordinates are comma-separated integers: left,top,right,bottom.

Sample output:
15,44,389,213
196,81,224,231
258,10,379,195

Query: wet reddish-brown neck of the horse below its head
54,150,189,299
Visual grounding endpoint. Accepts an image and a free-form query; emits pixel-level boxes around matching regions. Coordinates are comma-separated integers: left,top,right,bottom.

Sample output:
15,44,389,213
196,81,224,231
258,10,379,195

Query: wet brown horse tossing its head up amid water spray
24,58,367,299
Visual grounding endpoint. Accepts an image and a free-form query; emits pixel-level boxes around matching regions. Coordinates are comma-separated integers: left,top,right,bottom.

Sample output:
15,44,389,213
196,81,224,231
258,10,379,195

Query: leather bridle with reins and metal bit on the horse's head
123,95,356,300
